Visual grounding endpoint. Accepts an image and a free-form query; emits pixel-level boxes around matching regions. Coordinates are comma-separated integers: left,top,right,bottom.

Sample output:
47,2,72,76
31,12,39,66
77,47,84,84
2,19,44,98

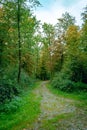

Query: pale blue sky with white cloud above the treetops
34,0,87,26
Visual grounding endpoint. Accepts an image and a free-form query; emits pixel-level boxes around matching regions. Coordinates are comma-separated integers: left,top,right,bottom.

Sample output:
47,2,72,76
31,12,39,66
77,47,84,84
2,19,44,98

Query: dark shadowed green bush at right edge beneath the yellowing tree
61,54,87,83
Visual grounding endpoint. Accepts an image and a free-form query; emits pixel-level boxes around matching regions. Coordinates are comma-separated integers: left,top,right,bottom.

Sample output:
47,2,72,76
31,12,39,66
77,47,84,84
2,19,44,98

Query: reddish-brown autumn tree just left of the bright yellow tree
50,40,65,74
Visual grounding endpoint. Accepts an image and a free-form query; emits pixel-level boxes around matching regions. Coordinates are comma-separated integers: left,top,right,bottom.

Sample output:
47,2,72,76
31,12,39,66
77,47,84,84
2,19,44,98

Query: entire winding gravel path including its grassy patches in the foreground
23,81,87,130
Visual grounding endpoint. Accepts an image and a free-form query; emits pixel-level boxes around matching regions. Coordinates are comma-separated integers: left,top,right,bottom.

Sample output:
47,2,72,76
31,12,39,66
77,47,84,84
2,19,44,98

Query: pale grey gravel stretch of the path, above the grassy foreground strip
35,82,76,119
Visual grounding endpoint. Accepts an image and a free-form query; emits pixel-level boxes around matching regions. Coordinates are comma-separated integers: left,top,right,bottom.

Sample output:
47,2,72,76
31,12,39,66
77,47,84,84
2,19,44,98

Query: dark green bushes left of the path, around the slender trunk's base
0,67,34,104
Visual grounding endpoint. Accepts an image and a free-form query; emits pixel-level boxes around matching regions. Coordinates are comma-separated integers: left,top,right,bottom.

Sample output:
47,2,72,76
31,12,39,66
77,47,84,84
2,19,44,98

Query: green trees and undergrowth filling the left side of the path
0,0,39,103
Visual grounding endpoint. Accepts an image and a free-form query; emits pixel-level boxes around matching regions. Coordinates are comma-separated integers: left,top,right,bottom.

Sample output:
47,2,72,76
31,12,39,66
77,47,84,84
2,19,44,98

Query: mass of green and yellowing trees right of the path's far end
35,8,87,91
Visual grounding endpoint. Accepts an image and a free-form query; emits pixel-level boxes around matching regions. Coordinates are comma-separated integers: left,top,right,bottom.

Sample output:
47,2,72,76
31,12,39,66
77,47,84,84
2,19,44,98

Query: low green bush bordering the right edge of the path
51,73,87,92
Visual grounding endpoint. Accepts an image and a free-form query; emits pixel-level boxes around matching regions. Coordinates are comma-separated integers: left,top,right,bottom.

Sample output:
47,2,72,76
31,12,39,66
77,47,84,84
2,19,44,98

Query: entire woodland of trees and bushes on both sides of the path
0,0,87,109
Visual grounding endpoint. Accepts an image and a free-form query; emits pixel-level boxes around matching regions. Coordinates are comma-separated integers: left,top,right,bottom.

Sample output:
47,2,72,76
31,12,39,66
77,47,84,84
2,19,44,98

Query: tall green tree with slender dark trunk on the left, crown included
0,0,40,82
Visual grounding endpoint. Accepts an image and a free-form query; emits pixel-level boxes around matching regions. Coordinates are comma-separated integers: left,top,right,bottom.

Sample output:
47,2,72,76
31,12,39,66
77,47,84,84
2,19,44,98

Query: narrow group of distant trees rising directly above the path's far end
36,23,55,80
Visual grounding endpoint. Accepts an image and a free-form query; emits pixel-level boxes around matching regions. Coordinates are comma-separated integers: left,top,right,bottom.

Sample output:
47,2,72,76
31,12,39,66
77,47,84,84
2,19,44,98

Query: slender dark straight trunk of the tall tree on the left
17,0,21,83
